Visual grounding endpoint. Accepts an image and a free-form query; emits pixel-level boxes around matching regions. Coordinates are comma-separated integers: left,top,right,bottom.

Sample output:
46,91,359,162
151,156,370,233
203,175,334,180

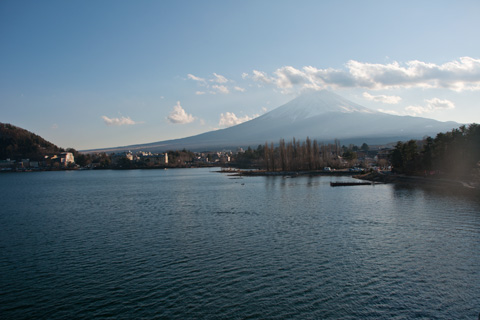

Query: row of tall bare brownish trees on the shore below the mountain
236,137,362,171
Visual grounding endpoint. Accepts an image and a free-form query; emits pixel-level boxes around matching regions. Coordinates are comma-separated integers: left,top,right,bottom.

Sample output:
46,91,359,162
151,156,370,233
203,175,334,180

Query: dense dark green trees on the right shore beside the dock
390,123,480,177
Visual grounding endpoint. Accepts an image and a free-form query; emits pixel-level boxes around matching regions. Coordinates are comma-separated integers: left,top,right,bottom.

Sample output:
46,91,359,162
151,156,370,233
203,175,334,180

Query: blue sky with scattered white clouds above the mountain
0,0,480,150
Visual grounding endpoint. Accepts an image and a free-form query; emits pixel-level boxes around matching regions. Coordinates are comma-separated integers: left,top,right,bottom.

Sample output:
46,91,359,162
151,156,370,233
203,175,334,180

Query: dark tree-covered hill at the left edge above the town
0,123,64,161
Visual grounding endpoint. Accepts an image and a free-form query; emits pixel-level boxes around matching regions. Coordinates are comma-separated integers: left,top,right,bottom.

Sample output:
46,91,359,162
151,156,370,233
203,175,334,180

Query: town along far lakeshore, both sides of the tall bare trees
0,145,392,172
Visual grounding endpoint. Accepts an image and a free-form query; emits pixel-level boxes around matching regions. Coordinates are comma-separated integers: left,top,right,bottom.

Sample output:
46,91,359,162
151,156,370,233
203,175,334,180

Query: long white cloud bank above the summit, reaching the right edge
252,57,480,91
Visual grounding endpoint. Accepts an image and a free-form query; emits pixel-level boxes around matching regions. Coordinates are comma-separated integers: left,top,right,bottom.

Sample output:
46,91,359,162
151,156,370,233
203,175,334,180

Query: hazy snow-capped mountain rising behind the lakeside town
85,90,460,152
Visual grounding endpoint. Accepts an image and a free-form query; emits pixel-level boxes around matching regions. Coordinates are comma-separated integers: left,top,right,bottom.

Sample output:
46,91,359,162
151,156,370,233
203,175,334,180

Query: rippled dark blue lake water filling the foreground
0,169,480,319
